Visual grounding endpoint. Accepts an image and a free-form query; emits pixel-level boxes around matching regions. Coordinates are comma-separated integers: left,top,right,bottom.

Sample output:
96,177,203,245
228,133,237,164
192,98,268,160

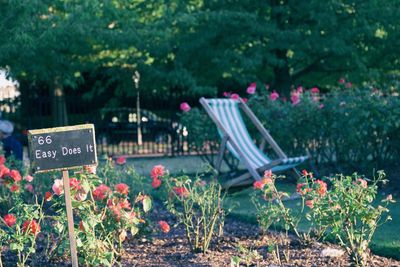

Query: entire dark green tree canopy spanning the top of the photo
0,0,400,109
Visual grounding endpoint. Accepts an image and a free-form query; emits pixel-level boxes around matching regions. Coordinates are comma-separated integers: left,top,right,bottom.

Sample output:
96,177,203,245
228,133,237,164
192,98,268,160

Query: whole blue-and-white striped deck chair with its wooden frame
200,97,308,188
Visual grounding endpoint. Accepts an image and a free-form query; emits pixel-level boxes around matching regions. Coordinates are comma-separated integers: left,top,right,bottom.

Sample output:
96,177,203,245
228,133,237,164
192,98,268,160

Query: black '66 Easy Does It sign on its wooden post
28,124,97,267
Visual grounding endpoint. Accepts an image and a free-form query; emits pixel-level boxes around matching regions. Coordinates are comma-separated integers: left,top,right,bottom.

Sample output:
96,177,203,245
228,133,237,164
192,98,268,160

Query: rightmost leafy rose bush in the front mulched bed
298,172,394,266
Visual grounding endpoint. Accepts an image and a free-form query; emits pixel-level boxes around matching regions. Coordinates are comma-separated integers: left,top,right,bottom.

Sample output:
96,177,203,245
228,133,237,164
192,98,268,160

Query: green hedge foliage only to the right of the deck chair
249,86,400,171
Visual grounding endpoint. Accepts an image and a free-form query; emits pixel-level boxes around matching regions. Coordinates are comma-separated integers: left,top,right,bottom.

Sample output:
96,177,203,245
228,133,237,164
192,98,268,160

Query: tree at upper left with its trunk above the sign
0,0,146,126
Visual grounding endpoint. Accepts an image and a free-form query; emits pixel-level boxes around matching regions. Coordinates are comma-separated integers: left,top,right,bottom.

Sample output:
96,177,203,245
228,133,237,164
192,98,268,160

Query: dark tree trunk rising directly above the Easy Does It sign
52,79,68,126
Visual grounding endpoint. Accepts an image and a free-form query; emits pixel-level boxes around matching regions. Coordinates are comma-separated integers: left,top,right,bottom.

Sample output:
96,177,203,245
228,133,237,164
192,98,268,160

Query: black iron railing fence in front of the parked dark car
0,97,216,156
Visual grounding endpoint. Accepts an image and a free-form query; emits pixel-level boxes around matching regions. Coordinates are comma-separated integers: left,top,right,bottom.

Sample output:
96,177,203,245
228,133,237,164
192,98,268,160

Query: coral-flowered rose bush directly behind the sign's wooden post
45,165,151,266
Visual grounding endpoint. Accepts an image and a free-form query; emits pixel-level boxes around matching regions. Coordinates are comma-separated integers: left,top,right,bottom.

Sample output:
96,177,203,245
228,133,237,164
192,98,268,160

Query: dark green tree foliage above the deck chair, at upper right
140,0,400,95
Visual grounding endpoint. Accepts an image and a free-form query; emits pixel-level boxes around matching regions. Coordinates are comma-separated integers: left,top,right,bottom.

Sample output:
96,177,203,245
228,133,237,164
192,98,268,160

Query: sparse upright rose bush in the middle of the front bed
151,165,225,253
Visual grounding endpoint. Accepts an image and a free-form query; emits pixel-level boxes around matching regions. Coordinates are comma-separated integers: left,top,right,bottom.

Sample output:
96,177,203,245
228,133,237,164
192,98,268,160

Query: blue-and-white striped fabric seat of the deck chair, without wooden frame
207,99,308,171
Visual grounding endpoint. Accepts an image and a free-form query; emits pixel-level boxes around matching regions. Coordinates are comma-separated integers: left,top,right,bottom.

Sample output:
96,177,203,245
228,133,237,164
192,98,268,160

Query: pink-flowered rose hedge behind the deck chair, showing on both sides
181,81,400,183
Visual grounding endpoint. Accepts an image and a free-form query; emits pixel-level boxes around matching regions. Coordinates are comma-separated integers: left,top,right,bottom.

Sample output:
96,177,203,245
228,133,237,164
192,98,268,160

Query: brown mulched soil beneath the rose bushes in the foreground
122,202,400,267
